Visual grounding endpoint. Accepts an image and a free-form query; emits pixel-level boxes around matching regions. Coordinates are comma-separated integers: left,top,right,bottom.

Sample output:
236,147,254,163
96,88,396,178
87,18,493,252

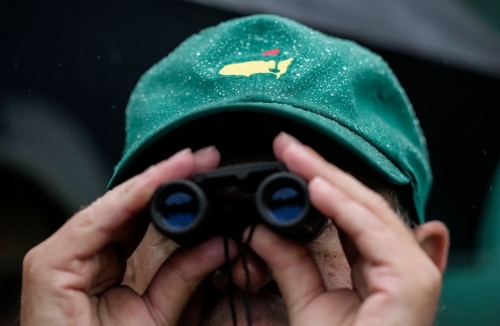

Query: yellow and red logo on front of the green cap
219,49,293,79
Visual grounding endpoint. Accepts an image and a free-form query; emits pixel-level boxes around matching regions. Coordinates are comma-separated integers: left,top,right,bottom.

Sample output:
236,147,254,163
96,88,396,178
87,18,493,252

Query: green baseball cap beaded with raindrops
108,15,432,222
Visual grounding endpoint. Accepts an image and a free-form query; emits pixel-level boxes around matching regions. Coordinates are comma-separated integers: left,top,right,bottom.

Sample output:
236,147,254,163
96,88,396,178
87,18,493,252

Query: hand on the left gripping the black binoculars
21,148,236,326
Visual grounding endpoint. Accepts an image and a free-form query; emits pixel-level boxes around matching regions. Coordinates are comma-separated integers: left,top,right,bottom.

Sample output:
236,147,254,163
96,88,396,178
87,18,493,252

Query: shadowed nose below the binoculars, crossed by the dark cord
213,249,272,292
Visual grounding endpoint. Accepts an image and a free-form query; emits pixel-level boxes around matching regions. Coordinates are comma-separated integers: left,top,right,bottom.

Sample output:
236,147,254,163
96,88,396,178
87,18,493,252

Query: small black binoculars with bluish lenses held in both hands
149,162,327,246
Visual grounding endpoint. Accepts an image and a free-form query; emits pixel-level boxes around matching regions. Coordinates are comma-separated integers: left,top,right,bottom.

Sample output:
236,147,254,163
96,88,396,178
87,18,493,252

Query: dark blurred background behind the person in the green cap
0,0,500,325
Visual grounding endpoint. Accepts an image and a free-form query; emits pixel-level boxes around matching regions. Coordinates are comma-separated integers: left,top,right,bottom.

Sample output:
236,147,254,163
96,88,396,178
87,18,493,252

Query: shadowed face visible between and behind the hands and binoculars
124,143,390,325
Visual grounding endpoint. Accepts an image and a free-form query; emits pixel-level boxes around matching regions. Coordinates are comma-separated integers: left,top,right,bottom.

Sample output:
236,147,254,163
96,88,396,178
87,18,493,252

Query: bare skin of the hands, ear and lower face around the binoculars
21,133,449,325
